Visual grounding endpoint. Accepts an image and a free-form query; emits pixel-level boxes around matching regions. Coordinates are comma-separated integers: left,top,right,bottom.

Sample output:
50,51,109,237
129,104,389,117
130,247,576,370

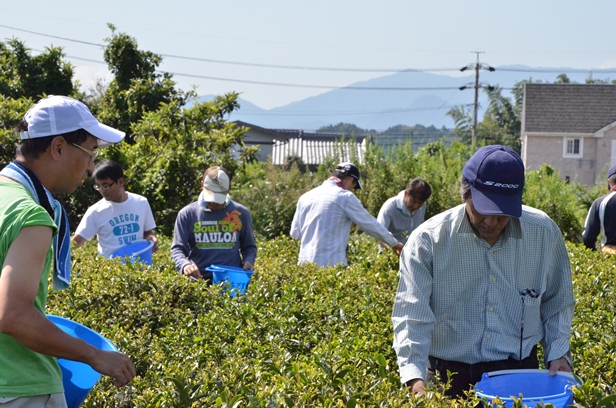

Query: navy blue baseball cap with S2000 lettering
462,145,524,218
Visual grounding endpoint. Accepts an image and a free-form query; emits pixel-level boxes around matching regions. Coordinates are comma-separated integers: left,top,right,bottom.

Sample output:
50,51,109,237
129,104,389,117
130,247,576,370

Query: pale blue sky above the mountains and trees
0,0,616,109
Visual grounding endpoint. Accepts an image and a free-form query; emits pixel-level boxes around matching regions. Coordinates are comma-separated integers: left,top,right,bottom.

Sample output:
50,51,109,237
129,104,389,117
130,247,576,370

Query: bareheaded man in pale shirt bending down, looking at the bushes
376,178,432,243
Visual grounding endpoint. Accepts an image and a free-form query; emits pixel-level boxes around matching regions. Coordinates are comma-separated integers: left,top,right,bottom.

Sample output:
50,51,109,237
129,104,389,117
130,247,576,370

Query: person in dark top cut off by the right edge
582,165,616,254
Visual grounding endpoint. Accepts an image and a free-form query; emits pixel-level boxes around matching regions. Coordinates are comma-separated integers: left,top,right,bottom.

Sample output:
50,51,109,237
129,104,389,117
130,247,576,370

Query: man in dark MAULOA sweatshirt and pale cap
171,166,257,282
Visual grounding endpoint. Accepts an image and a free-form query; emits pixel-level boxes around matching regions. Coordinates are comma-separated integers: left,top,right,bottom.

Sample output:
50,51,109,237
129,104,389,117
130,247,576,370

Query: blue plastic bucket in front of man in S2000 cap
475,369,577,408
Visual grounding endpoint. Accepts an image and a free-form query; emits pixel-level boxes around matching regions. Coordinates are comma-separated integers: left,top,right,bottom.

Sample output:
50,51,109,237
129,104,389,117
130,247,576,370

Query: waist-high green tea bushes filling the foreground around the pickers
48,235,616,408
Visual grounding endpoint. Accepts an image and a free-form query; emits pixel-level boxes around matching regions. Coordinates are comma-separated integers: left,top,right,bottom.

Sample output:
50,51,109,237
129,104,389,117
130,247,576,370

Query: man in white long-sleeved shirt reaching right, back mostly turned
291,163,403,267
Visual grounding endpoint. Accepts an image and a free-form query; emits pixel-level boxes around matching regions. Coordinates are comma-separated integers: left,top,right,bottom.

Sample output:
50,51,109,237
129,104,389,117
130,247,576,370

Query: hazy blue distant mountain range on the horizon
191,65,616,130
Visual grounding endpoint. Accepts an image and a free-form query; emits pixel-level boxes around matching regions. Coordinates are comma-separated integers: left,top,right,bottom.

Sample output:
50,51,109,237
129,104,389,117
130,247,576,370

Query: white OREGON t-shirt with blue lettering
75,192,156,258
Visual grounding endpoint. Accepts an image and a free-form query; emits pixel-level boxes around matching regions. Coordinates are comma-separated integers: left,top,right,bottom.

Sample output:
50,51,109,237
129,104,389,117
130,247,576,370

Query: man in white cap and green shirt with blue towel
0,96,135,407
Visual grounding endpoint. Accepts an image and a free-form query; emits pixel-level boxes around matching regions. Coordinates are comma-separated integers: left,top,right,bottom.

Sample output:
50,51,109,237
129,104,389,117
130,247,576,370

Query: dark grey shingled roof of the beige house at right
522,83,616,133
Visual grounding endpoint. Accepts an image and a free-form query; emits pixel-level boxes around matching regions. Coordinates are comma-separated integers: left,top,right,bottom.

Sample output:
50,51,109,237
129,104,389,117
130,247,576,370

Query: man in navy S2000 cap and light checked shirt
392,145,575,396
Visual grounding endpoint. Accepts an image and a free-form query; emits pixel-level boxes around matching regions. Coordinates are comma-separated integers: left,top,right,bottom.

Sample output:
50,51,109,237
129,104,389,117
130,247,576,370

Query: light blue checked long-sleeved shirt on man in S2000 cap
392,204,575,383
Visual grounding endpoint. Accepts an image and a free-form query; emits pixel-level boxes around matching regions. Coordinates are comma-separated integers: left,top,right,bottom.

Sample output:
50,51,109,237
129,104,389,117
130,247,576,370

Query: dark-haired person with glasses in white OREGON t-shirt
71,160,158,258
